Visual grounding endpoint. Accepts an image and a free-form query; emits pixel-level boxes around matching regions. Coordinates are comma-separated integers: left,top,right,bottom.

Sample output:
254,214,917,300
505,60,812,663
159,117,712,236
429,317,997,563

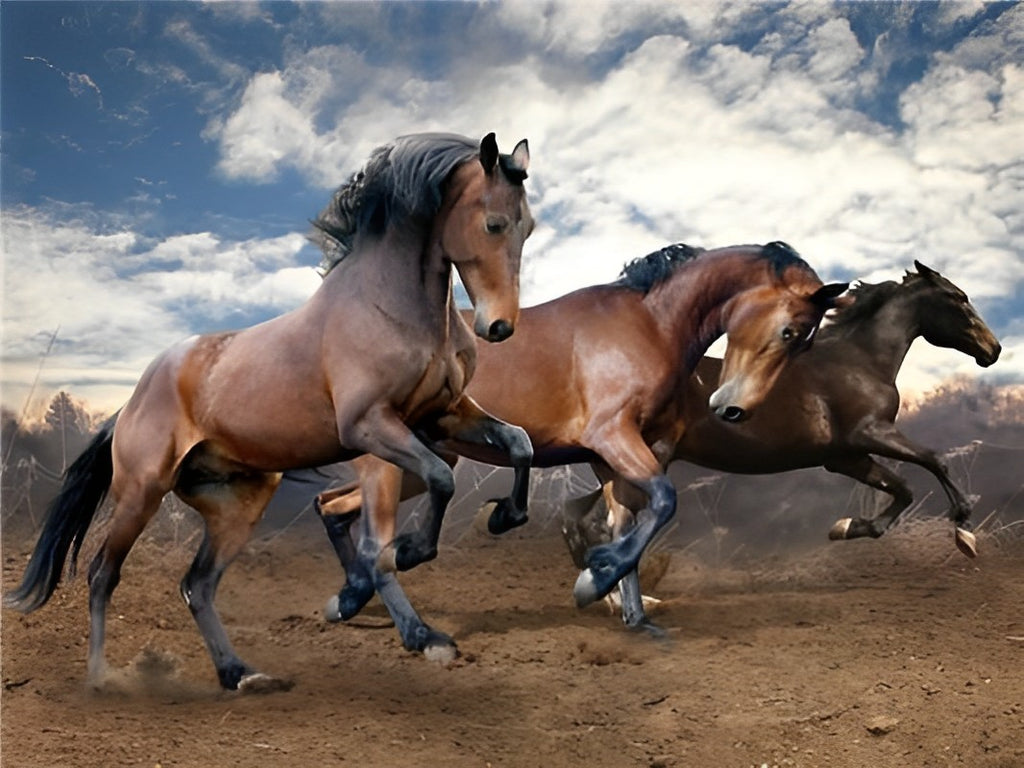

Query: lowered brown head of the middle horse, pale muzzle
709,262,847,422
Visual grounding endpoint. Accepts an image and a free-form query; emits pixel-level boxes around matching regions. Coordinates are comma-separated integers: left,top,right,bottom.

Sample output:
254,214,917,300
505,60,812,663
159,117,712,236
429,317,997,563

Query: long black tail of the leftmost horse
3,415,118,613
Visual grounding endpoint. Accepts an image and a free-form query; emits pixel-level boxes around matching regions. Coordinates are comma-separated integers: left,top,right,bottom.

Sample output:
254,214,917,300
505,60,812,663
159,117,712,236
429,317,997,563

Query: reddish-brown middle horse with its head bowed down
317,243,847,652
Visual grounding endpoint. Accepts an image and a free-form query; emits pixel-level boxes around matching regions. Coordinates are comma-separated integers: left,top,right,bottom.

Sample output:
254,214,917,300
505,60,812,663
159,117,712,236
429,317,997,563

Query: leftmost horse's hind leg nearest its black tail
88,485,164,687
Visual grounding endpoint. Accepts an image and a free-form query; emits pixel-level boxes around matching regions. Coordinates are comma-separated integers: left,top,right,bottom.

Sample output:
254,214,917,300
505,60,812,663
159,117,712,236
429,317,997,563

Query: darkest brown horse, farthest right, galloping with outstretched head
562,261,1000,615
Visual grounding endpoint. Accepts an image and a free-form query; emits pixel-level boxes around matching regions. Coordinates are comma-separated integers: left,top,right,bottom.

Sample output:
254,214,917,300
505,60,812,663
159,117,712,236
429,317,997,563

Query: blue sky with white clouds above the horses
0,0,1024,421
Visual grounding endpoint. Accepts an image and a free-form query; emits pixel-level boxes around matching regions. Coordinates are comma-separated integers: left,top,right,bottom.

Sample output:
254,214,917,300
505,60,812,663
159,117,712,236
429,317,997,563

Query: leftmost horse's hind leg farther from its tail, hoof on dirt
177,472,291,691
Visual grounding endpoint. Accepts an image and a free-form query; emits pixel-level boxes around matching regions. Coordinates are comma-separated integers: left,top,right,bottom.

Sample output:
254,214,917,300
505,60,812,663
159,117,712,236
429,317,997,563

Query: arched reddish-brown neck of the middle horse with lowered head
645,256,767,375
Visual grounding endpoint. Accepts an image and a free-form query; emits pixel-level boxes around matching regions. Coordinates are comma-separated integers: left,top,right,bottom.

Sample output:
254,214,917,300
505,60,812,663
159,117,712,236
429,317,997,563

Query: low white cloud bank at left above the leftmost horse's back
2,207,319,411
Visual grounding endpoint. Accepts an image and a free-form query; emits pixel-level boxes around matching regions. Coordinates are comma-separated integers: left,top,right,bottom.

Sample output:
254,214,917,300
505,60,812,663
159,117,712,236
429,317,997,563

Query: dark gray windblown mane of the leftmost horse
309,133,479,274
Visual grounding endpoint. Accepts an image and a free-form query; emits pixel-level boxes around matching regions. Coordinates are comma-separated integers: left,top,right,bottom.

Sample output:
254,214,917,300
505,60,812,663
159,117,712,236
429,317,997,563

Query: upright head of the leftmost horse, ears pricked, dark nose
439,133,534,341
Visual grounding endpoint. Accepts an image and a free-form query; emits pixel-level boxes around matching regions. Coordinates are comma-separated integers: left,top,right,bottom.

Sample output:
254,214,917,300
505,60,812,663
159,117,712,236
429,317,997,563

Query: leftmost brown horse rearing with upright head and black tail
5,133,532,690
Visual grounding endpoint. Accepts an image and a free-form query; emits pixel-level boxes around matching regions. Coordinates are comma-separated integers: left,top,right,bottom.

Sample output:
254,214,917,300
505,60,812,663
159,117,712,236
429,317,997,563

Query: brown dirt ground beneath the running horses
0,507,1024,768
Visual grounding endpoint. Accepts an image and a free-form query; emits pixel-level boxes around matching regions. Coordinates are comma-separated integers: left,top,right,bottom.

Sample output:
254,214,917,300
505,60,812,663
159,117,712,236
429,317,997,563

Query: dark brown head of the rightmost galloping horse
904,261,1001,368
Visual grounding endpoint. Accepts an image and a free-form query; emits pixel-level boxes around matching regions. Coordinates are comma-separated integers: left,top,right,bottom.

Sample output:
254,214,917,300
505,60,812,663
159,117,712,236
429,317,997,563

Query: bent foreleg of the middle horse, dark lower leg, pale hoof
572,417,676,606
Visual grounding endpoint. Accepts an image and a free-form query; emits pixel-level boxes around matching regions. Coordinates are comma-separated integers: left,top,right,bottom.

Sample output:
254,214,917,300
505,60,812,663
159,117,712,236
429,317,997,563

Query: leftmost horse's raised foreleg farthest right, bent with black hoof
428,395,534,536
